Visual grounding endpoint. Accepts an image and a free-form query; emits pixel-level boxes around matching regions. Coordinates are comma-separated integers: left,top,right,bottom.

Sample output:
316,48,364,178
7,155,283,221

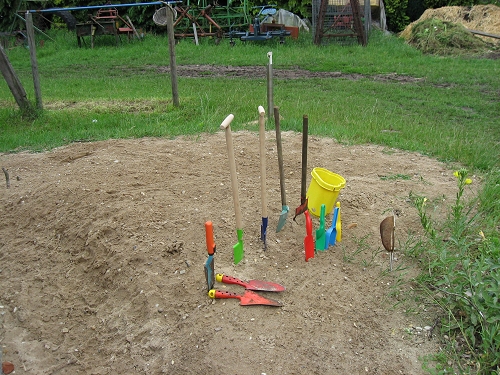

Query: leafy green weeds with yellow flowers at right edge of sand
410,169,500,374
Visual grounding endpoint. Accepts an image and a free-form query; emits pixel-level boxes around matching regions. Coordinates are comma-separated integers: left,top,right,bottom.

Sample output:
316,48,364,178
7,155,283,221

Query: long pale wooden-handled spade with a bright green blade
220,114,244,264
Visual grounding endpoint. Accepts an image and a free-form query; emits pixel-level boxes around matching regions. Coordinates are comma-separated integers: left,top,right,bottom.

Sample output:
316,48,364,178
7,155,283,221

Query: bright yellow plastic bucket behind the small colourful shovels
307,168,345,217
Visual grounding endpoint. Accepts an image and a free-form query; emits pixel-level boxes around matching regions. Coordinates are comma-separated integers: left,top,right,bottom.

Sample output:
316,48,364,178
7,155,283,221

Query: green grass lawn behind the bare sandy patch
0,32,500,170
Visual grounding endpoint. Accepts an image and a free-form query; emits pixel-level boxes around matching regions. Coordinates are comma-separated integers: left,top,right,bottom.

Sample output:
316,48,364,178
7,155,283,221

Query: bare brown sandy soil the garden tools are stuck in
0,129,468,375
